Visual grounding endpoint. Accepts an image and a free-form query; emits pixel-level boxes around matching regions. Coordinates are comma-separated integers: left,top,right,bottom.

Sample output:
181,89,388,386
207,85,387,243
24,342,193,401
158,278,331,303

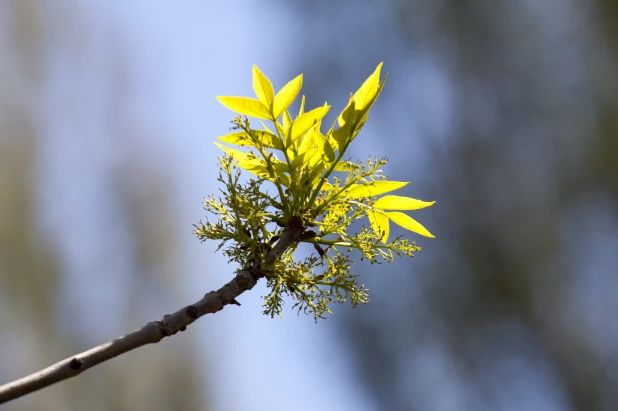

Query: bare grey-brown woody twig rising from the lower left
0,217,304,404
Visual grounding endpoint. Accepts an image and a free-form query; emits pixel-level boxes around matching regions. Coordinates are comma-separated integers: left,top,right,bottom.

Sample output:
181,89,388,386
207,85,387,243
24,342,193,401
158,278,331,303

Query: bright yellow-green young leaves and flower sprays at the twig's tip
195,63,434,319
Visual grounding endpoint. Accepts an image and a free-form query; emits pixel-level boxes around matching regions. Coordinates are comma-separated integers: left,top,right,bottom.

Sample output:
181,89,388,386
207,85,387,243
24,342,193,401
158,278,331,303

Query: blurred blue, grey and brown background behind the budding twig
0,0,618,411
